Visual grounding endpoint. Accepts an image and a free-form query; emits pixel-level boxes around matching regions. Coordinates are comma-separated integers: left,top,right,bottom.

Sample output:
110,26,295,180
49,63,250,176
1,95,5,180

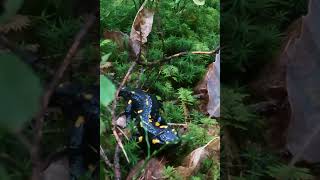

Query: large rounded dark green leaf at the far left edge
0,53,42,131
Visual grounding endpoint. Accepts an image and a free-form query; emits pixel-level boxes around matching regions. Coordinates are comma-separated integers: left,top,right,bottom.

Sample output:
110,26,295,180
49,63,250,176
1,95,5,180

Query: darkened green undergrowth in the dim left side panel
0,0,99,180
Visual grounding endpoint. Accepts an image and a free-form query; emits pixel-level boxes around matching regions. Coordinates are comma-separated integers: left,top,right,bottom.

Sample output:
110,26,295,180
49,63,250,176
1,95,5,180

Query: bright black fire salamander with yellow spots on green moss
119,88,179,145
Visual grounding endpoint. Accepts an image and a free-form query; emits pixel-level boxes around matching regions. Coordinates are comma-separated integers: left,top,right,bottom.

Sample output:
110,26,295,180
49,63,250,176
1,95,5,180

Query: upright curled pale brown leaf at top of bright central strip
130,1,154,56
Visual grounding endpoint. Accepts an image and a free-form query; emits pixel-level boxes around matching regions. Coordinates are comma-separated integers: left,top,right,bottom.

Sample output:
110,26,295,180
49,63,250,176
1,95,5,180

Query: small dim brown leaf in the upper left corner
0,14,30,33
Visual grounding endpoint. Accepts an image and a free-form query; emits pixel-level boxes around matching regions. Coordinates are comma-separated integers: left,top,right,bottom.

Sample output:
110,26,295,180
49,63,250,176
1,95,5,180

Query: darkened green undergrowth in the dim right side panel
220,0,312,180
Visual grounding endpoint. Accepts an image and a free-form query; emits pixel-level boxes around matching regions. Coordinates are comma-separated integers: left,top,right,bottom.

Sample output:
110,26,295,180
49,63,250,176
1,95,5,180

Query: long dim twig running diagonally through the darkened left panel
30,15,96,180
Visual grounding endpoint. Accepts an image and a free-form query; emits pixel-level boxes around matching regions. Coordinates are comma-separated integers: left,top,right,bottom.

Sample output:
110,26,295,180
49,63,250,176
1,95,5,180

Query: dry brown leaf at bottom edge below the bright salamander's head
127,158,165,180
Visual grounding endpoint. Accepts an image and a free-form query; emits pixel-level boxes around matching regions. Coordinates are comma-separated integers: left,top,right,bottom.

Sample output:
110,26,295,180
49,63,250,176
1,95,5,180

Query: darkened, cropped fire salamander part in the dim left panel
52,83,100,180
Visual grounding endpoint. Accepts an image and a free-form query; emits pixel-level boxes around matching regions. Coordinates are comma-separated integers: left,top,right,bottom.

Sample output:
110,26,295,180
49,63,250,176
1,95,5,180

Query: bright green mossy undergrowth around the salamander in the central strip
100,0,220,179
